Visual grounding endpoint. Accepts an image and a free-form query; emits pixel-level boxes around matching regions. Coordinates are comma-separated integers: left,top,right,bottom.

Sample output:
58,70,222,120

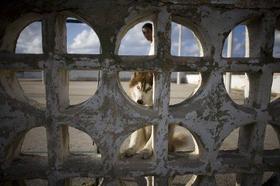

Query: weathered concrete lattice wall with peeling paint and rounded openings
0,0,280,186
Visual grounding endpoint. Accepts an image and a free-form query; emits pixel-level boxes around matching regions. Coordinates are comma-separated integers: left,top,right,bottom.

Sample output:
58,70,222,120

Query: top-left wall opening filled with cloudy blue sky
16,22,42,54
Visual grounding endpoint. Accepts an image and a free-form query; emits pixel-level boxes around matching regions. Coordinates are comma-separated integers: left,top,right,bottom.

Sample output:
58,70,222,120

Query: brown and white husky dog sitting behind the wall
124,72,196,159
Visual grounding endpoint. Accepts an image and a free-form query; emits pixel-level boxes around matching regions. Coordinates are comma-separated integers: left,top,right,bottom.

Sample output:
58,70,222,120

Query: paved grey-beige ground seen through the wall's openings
20,80,279,186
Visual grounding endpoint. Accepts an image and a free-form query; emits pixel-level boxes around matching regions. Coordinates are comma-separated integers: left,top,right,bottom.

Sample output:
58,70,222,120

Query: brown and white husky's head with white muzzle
129,72,153,106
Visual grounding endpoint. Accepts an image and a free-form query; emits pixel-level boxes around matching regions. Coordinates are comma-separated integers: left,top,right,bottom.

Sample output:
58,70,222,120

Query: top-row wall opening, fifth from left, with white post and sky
222,25,249,58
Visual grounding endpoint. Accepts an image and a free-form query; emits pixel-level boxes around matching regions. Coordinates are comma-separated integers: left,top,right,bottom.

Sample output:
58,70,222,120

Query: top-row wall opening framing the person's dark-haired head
118,21,155,56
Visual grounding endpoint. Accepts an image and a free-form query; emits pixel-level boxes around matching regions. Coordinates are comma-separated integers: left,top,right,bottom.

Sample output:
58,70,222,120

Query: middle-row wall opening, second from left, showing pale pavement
69,70,101,105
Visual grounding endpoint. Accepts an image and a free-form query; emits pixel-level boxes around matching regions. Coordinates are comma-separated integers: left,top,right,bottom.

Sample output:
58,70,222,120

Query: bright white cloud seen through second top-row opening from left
67,28,100,54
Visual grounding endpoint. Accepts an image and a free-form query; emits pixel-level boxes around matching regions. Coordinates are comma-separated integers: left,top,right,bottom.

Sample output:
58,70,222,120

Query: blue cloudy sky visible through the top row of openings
16,19,280,57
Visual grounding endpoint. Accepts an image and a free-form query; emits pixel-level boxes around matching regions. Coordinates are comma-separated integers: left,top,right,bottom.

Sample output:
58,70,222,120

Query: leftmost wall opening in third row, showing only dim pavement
21,127,48,156
